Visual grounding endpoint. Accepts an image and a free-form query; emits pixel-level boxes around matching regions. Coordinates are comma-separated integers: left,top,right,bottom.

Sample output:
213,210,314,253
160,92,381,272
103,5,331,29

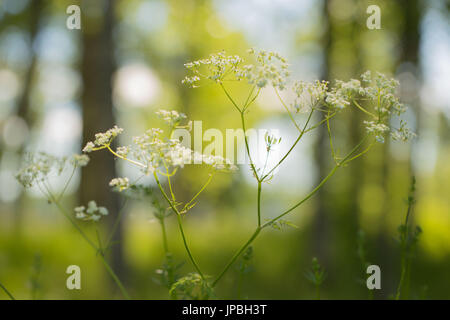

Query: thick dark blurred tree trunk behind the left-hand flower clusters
80,0,125,288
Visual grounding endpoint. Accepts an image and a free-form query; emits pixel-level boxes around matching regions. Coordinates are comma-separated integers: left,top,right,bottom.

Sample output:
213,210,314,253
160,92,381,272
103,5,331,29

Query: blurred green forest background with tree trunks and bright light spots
0,0,450,299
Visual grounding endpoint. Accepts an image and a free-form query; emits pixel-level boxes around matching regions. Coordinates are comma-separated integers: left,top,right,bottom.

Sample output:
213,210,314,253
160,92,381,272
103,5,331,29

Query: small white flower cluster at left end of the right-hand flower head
292,80,328,113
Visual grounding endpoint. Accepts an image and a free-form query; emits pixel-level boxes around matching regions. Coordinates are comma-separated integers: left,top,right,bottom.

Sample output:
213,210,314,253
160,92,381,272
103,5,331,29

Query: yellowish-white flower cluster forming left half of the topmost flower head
182,51,244,88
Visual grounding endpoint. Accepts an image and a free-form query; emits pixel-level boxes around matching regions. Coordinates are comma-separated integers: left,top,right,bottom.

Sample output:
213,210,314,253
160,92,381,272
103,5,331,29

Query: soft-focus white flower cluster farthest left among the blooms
16,152,89,188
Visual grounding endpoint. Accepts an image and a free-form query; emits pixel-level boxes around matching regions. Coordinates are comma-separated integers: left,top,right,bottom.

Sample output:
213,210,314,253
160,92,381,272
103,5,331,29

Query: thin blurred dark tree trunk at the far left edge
14,0,44,235
